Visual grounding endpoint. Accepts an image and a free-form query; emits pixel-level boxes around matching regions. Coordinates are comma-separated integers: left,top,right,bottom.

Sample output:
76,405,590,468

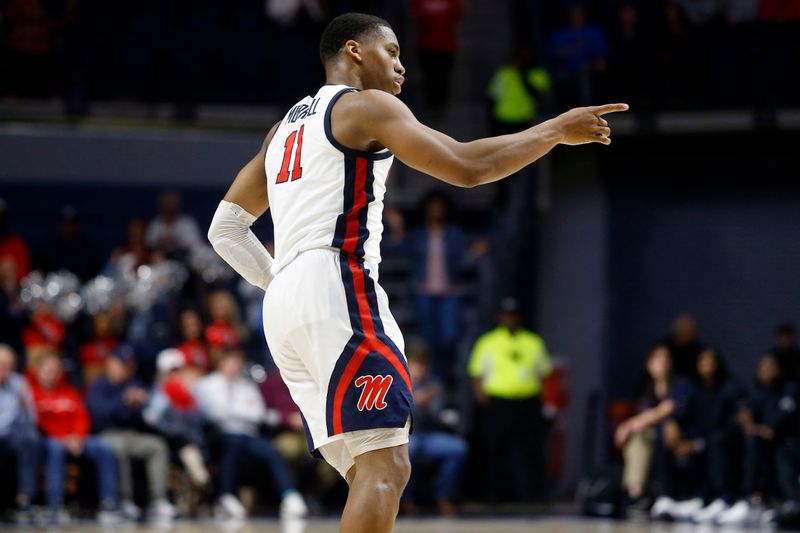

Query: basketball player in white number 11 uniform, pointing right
208,13,628,533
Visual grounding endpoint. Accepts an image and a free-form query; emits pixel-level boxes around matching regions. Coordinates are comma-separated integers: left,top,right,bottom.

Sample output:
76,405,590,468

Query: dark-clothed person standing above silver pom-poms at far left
39,206,100,282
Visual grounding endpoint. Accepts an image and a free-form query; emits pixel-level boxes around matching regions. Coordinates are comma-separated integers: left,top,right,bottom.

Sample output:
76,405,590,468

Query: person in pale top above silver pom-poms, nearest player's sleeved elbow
145,193,205,258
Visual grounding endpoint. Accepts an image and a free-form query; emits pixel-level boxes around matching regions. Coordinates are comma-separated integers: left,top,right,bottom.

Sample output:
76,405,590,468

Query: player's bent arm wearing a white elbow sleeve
208,124,278,290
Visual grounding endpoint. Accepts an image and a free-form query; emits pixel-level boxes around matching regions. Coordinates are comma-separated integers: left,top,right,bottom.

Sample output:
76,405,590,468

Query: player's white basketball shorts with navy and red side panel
264,249,413,476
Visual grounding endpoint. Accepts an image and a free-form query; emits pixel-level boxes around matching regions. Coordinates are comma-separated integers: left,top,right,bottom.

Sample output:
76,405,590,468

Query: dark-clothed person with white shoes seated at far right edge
717,354,798,525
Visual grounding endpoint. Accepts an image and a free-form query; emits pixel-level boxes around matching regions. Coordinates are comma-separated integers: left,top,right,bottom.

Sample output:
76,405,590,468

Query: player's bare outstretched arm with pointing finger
337,90,628,187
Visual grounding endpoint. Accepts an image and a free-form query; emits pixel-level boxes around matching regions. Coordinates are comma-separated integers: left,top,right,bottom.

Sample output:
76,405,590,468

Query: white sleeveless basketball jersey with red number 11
264,85,394,279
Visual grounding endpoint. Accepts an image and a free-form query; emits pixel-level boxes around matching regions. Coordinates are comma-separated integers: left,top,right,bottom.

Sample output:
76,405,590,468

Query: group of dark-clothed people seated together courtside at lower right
614,315,800,526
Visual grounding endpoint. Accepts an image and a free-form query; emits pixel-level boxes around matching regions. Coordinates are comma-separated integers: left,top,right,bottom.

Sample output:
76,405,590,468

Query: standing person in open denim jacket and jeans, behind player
408,191,470,382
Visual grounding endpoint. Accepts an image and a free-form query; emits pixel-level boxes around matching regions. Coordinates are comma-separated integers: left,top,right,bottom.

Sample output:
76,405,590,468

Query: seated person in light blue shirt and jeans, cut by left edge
0,344,39,525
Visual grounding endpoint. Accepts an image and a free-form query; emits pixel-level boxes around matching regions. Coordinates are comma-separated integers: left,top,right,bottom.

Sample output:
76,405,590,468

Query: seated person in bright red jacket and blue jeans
31,354,123,525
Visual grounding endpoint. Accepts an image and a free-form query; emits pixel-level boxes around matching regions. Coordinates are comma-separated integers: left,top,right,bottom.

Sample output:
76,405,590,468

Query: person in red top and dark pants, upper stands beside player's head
411,0,464,109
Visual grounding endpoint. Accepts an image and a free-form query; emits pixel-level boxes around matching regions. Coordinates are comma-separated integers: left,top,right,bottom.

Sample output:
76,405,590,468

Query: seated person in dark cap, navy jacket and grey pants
86,345,175,523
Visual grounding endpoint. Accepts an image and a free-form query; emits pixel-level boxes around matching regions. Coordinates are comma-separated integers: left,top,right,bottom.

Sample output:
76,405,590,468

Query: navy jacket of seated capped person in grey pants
86,376,147,432
